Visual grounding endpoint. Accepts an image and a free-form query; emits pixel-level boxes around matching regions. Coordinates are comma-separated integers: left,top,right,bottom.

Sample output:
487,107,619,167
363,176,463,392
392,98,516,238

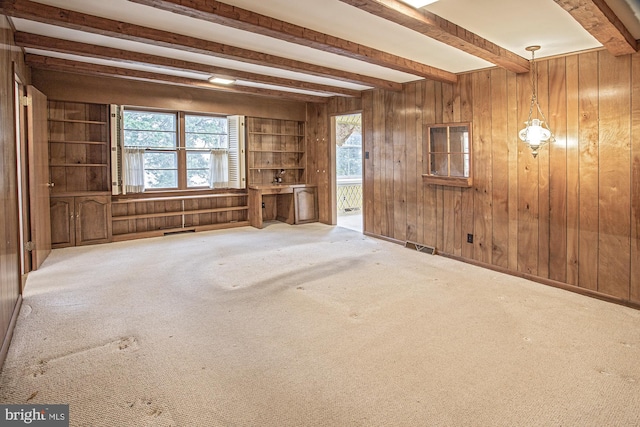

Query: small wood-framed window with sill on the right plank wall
422,123,473,187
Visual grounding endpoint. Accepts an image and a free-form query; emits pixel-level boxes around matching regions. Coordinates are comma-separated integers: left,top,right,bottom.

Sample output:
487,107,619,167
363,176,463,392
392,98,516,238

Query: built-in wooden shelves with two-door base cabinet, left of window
48,100,111,248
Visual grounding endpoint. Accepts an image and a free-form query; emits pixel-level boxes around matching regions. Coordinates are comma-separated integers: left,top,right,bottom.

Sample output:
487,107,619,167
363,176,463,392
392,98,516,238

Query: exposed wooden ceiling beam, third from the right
129,0,457,83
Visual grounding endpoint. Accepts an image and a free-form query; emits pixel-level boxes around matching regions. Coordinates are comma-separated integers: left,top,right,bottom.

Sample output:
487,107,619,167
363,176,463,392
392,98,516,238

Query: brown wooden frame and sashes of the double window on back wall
123,106,231,193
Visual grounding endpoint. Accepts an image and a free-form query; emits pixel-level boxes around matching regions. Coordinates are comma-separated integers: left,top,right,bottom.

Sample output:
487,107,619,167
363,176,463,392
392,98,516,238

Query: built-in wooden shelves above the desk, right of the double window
246,117,307,186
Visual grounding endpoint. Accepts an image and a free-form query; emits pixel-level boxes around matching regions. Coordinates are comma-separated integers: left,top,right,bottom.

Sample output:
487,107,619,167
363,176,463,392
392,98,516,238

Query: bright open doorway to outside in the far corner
333,113,363,232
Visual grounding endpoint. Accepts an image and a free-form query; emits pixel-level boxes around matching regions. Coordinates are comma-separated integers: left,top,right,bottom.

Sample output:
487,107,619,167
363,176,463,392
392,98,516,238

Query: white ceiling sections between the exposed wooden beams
7,0,640,96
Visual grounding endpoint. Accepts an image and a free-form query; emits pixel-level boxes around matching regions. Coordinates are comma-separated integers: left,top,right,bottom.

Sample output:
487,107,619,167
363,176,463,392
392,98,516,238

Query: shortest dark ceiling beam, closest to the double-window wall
25,54,329,103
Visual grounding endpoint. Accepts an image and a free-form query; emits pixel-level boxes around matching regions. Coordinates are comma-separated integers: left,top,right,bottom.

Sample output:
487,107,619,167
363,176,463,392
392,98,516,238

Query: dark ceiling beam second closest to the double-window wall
14,31,361,97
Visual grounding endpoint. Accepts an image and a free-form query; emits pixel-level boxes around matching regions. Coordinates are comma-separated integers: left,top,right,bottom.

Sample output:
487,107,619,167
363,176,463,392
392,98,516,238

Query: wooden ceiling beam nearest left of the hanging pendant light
340,0,529,73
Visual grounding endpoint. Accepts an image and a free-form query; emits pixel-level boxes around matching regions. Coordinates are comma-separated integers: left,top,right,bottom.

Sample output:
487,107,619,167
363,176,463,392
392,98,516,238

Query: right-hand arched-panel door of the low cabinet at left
75,196,111,246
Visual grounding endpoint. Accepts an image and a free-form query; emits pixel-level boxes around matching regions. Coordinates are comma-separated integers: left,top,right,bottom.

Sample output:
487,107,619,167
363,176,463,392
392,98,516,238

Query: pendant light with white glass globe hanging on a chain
518,46,555,158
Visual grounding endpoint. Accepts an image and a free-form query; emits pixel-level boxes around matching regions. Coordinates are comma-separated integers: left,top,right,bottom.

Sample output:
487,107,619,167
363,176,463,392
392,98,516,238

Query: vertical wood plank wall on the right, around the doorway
332,51,640,304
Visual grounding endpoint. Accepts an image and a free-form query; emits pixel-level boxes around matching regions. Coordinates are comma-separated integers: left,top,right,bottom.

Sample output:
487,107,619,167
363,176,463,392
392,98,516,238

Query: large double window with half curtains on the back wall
121,109,244,192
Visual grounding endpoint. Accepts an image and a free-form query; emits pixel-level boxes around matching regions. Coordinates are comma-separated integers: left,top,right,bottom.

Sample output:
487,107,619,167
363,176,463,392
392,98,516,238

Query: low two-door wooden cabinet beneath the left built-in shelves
51,195,111,248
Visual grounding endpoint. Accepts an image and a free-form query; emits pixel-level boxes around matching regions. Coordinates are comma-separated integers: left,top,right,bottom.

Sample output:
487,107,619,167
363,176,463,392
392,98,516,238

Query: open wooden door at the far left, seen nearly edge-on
27,86,51,270
